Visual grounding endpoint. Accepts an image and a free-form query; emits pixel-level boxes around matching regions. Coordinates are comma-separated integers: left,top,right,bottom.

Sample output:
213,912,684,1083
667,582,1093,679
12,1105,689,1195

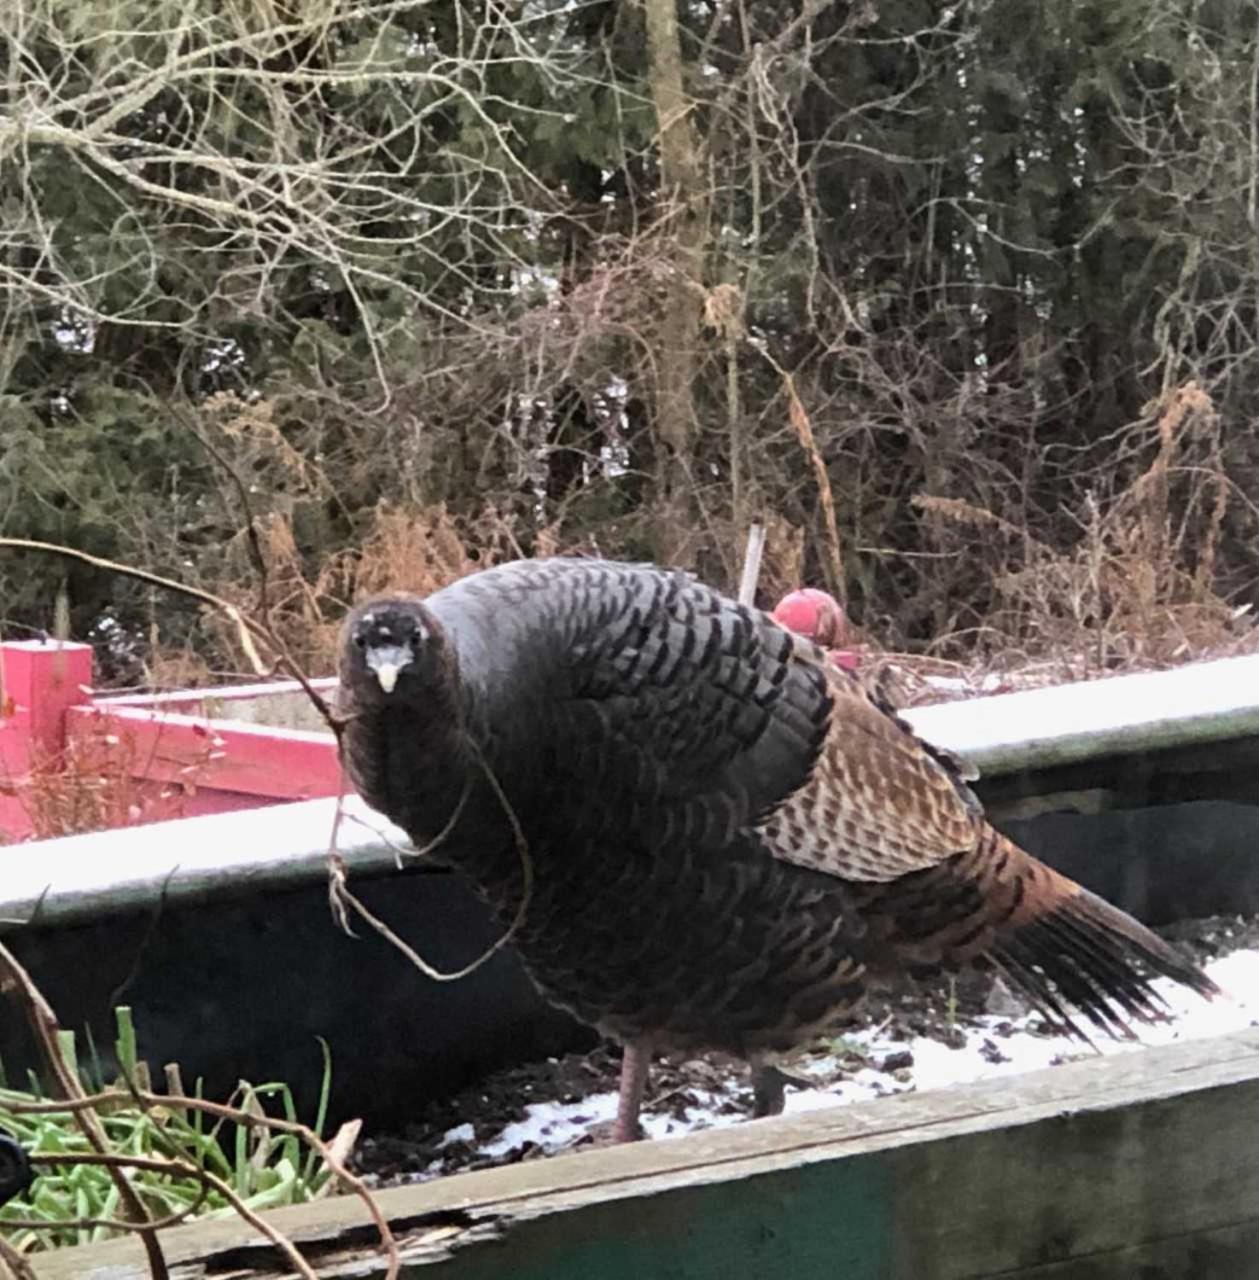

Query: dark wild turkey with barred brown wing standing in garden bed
339,559,1215,1139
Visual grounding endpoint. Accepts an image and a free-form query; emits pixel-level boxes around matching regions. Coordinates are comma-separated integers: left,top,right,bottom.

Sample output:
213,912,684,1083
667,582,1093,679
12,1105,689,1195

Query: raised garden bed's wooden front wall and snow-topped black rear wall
7,658,1259,1280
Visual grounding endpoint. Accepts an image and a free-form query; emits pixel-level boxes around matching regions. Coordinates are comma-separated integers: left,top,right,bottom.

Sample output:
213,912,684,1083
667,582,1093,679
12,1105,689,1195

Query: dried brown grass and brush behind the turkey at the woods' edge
133,378,1251,701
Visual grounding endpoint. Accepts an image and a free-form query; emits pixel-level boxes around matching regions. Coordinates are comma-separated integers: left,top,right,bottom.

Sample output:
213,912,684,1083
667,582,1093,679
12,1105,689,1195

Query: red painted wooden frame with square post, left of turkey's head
0,640,340,841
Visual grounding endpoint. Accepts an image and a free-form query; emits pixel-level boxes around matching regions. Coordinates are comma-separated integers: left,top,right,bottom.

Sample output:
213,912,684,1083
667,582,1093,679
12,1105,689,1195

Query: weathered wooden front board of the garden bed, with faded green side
37,1030,1259,1280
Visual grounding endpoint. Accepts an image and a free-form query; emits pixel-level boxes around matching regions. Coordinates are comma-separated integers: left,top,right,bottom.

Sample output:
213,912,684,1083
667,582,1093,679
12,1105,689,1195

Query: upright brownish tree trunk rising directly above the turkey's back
644,0,710,566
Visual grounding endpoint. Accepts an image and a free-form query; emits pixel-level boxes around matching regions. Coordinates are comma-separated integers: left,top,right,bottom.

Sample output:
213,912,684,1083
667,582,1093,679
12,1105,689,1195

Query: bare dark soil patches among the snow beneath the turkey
357,916,1259,1185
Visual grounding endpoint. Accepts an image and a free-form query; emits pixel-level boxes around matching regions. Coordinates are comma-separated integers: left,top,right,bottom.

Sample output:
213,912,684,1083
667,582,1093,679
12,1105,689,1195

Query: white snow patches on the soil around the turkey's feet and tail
442,951,1259,1172
